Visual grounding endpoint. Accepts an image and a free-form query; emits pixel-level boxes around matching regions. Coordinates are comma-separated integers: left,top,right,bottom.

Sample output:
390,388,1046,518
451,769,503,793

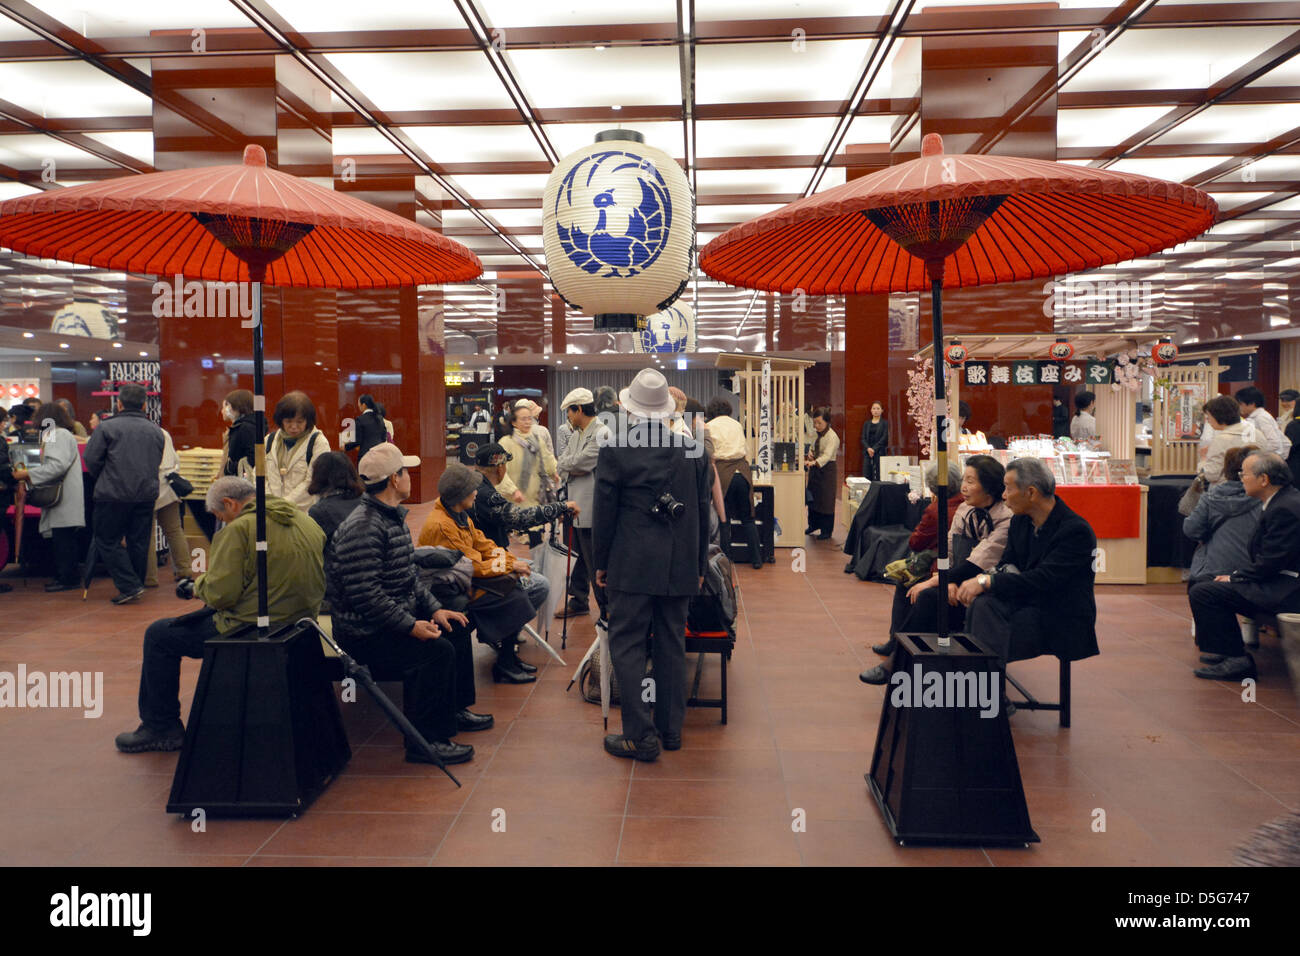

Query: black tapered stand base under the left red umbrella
166,624,352,817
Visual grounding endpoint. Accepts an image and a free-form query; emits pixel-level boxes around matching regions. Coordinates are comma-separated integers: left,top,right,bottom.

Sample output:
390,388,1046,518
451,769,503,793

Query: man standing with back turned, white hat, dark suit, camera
592,368,712,761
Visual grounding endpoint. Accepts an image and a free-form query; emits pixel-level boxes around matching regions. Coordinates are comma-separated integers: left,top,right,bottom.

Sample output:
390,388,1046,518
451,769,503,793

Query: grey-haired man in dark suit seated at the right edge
1187,451,1300,680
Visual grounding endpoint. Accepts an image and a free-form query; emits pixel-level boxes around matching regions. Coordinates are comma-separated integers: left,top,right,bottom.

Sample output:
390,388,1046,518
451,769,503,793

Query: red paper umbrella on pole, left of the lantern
0,146,482,633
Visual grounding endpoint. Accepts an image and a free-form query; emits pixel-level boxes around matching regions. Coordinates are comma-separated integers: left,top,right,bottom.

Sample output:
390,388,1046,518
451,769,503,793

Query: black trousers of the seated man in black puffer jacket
339,633,460,749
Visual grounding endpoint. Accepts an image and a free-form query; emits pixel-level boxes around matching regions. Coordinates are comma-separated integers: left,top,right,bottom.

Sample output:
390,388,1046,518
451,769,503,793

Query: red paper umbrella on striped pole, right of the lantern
699,133,1218,644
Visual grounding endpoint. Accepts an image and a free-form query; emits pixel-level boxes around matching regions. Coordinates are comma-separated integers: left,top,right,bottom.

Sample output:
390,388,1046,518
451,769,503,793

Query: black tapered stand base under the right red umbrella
866,633,1039,845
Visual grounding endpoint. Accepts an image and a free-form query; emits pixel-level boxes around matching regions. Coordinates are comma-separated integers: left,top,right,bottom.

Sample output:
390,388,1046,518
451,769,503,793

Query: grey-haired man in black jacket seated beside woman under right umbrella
957,458,1100,661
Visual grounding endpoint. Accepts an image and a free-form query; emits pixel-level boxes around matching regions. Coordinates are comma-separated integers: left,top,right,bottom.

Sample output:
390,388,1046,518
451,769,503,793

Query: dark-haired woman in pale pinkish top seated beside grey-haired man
858,455,1011,684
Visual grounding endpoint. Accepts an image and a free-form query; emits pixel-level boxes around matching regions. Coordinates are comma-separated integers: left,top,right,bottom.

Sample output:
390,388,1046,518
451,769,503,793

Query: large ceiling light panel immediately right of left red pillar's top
326,51,514,111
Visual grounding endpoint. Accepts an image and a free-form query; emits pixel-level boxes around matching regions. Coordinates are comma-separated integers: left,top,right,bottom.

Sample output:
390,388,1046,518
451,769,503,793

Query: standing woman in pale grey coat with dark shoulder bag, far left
13,402,86,592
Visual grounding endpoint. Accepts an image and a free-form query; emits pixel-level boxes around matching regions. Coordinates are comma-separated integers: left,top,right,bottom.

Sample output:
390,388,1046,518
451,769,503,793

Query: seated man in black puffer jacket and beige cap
325,442,493,763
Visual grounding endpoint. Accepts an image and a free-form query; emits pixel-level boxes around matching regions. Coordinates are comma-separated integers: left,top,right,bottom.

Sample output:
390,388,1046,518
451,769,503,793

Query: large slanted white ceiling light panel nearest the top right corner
1062,26,1295,92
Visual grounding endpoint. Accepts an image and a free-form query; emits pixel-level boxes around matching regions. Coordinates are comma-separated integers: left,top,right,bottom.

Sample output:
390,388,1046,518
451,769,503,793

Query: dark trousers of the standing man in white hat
608,588,690,740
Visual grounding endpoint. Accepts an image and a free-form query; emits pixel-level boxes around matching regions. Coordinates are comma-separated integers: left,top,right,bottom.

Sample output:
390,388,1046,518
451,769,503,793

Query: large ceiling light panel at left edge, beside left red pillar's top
0,60,153,117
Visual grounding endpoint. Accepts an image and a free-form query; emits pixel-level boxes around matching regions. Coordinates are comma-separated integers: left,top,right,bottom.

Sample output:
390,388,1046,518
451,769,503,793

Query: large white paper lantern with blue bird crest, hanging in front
542,130,696,329
